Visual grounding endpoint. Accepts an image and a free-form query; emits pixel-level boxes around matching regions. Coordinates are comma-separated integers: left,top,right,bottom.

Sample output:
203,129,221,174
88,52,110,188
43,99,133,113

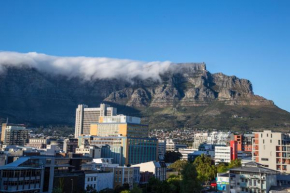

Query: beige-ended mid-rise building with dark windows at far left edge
1,123,29,146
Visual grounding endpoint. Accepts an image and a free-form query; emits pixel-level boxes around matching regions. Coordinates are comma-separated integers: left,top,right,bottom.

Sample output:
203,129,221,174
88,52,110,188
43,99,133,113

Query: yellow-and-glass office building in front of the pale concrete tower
89,115,158,165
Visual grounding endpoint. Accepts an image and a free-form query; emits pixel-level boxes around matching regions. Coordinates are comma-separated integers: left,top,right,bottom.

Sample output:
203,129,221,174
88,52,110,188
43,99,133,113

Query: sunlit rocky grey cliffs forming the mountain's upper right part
105,64,273,108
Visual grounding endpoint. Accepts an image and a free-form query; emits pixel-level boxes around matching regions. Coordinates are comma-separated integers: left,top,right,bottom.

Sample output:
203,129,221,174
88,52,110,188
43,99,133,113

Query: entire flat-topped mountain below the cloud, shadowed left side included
0,63,290,128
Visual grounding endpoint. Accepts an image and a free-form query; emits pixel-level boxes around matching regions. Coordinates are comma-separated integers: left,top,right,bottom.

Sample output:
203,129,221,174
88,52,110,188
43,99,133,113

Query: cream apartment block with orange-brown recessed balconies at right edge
252,130,290,173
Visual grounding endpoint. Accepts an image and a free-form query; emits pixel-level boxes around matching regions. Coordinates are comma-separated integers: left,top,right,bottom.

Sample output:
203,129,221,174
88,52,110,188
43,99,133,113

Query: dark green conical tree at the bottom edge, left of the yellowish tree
180,163,201,193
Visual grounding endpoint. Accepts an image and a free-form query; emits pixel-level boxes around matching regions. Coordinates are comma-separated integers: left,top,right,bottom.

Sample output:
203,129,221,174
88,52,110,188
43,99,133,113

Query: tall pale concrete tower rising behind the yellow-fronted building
75,104,117,138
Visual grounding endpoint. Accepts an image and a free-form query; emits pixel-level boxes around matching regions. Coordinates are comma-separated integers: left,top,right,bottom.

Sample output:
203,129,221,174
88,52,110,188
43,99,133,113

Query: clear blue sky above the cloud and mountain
0,0,290,111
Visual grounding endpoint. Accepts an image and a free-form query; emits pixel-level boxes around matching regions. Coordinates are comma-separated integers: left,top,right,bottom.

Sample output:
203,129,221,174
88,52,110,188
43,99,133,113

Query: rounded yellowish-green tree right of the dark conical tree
194,154,217,185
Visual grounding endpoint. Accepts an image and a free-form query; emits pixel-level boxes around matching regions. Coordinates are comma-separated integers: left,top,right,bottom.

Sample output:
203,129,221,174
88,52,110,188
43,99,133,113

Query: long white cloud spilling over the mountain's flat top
0,51,176,80
